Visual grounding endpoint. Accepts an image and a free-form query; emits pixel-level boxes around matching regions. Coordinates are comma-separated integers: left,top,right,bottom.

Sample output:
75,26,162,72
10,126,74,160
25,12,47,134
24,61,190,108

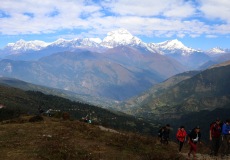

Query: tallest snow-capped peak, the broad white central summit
101,28,142,48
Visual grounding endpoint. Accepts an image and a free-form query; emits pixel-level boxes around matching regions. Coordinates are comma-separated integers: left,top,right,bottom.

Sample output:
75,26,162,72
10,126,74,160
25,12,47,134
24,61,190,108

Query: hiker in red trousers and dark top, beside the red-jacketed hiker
188,126,201,159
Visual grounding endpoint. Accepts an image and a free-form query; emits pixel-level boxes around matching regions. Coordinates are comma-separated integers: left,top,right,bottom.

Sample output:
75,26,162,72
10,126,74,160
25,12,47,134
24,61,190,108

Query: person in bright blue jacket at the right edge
221,119,230,157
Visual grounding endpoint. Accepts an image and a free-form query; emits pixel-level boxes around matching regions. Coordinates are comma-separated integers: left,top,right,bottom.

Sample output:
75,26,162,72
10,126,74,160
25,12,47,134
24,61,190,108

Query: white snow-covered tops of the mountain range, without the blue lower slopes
0,29,229,57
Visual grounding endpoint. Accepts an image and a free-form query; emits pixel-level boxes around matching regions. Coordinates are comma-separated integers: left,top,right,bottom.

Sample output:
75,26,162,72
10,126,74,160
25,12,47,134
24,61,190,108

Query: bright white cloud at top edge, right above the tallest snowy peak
103,0,194,17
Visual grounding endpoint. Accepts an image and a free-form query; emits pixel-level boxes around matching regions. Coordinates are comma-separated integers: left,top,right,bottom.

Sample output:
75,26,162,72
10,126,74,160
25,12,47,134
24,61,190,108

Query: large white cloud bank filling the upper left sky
0,0,99,34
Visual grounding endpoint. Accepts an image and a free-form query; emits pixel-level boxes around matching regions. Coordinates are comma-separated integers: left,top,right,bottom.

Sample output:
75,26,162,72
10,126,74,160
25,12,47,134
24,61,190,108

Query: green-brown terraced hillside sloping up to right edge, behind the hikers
125,61,230,119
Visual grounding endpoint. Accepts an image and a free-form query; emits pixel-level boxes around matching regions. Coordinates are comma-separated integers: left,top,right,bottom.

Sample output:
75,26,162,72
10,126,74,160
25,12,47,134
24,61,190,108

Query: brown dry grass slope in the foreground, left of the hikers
0,116,186,160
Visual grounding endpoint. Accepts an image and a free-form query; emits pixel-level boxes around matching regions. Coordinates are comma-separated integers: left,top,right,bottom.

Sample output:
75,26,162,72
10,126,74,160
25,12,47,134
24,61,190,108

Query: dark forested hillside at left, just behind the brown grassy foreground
0,85,156,134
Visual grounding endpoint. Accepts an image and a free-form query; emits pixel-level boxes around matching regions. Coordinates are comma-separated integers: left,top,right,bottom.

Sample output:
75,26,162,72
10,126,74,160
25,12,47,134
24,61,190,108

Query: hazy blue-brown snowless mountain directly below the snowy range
0,47,184,100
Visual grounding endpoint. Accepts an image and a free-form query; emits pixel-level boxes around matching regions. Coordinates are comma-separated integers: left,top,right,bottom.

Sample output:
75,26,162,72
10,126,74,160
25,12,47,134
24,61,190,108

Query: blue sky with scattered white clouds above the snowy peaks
0,0,230,50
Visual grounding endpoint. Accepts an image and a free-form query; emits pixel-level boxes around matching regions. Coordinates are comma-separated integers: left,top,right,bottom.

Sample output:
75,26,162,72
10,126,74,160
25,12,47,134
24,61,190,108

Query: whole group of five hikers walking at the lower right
158,118,230,158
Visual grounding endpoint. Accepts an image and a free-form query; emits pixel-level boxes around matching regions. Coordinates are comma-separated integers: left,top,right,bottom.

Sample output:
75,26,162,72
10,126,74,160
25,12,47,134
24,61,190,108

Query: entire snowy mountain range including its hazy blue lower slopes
0,28,230,69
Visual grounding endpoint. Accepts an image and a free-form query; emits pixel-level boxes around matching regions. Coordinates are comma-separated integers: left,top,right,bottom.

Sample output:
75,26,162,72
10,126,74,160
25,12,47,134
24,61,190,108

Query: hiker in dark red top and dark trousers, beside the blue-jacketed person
209,118,221,156
